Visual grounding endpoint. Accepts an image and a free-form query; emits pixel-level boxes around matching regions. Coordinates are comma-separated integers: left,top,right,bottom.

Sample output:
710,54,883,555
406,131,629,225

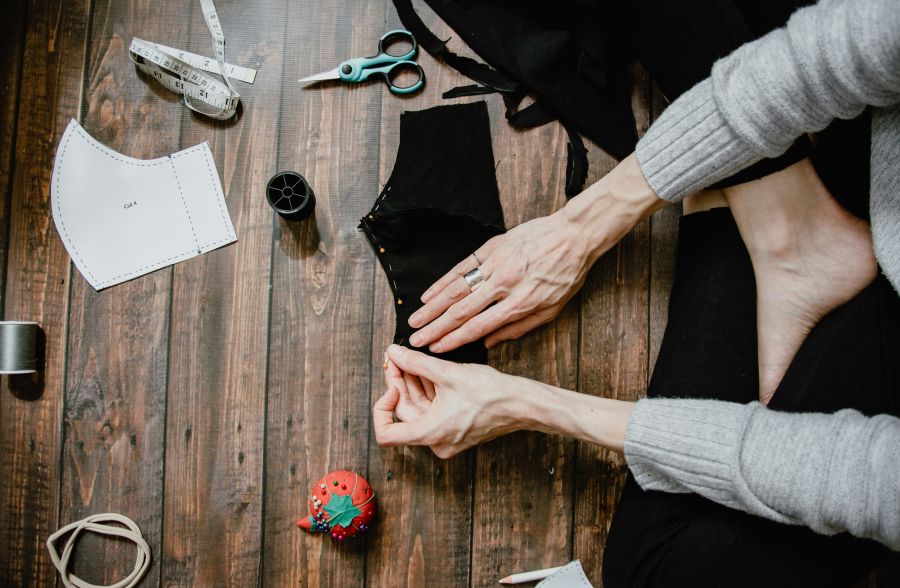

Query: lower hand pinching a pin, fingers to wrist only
373,345,541,459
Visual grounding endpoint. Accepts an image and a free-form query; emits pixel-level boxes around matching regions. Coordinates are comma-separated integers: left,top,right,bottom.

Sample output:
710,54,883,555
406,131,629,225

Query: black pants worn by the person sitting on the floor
603,0,884,588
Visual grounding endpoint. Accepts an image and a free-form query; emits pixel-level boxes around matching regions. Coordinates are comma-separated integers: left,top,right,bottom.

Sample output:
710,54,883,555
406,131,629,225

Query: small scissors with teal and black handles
300,29,425,94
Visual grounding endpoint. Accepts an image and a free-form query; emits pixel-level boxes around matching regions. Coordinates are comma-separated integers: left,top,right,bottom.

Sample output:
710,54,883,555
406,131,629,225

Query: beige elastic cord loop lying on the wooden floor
47,512,150,588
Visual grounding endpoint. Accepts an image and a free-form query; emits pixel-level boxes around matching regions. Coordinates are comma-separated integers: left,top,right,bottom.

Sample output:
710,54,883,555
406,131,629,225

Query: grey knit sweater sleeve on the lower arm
625,399,900,551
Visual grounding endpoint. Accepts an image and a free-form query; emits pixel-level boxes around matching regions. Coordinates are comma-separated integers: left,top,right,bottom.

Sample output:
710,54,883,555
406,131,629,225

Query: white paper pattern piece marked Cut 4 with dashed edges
50,120,237,290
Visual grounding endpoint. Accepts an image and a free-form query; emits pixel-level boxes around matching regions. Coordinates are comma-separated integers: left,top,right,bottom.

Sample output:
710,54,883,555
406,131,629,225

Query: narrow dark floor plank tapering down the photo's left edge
0,0,26,312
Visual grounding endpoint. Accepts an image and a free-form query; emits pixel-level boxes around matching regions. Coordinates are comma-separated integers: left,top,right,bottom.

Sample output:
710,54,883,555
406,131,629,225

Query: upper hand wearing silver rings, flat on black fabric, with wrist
409,156,664,353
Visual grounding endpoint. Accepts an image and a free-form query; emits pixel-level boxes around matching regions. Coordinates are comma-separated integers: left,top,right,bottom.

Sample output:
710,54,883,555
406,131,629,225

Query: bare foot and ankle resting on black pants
725,161,877,404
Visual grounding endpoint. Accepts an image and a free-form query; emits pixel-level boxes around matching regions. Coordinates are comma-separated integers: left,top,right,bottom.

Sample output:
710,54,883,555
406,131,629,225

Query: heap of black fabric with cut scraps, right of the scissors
394,0,637,196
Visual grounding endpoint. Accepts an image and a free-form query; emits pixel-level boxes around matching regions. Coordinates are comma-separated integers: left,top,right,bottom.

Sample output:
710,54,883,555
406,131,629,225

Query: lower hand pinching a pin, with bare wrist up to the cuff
372,345,634,459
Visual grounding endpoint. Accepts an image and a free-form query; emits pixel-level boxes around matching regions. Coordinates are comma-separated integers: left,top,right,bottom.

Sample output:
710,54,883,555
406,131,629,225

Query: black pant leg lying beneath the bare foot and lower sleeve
603,209,900,588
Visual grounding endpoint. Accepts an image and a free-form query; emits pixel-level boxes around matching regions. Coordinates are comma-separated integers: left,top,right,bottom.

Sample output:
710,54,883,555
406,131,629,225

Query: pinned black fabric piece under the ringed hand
360,102,505,363
